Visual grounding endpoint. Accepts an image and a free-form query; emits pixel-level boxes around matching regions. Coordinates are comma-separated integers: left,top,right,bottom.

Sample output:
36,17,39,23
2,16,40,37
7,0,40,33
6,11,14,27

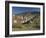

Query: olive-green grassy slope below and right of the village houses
12,14,40,31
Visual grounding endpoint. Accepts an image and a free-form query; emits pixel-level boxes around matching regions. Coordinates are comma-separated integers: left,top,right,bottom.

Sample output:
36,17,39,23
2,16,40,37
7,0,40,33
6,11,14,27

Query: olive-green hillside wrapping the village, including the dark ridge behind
12,12,40,31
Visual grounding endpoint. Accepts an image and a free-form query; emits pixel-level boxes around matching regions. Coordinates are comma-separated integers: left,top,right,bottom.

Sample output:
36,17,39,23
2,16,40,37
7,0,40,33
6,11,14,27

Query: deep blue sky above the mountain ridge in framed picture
12,7,40,14
